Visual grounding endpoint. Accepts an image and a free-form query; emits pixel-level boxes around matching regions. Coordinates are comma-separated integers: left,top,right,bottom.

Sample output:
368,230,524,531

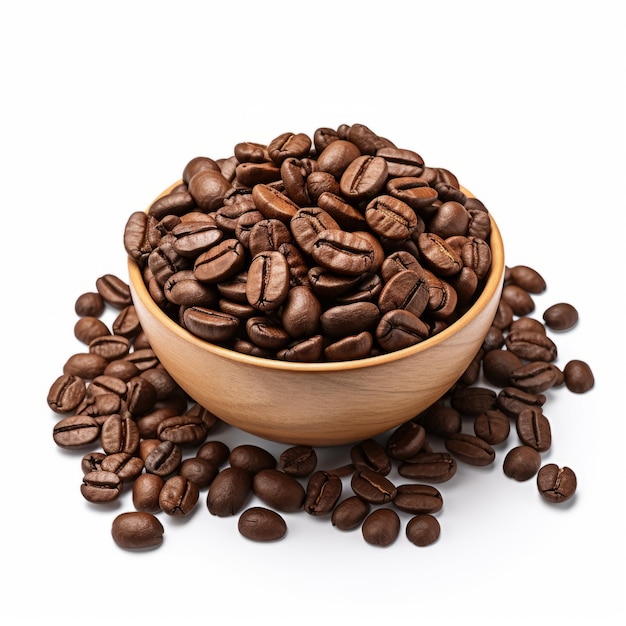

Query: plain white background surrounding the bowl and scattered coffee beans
0,0,626,625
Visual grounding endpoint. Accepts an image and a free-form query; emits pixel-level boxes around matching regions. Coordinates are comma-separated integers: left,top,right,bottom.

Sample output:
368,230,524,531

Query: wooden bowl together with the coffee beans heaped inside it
124,124,504,445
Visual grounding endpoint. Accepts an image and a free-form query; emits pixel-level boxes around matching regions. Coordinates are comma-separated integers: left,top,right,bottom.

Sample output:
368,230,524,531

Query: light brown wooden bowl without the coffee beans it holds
128,185,504,446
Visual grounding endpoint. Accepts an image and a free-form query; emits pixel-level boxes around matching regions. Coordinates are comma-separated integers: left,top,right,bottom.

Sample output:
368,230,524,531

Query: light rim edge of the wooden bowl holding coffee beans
128,181,505,372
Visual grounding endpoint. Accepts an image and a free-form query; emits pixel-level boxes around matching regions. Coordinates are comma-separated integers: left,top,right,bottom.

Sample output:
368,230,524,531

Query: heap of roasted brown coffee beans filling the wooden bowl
124,124,492,362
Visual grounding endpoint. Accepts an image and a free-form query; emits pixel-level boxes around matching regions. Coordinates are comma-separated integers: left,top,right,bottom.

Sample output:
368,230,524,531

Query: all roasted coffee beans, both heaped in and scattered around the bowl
47,124,594,550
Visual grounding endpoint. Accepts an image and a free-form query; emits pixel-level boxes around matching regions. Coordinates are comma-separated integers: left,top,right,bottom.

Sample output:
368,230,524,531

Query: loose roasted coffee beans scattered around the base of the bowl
47,258,595,551
